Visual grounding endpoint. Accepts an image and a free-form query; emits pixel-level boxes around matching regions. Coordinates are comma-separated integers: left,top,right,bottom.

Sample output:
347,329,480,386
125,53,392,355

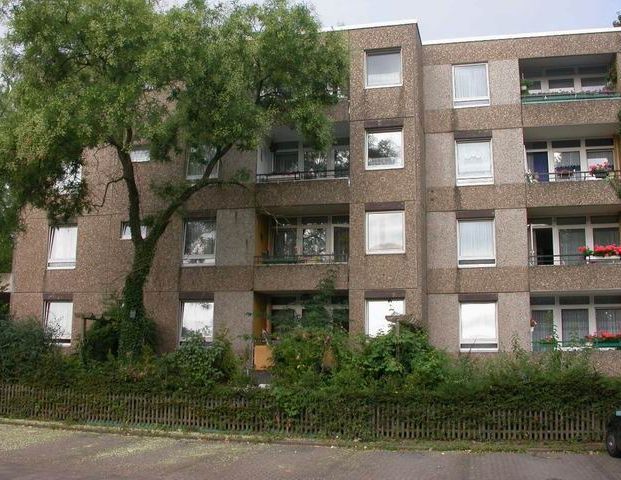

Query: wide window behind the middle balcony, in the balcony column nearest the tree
271,215,349,263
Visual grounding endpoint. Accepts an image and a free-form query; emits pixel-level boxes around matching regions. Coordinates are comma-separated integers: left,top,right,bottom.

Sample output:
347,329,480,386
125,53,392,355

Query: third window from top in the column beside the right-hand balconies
457,220,496,267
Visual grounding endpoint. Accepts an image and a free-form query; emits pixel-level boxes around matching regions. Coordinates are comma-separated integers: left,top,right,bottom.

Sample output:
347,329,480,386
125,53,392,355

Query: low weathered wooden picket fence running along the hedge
0,385,607,441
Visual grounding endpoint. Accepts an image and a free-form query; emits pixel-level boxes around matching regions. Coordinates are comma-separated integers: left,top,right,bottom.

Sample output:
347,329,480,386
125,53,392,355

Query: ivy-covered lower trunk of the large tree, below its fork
119,242,157,358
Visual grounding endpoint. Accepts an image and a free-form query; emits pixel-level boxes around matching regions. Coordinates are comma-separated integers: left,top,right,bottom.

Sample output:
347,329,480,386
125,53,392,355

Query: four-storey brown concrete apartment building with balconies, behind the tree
11,17,621,367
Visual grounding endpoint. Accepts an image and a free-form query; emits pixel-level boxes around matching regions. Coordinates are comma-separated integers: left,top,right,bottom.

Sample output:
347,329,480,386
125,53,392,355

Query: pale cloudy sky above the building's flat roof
0,0,621,41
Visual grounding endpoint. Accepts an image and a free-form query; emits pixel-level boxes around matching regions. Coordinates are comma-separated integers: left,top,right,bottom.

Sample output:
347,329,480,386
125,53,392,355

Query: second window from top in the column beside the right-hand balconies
455,140,494,185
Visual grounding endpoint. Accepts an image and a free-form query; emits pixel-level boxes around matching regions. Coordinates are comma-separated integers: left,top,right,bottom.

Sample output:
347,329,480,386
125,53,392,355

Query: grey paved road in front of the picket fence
0,425,621,480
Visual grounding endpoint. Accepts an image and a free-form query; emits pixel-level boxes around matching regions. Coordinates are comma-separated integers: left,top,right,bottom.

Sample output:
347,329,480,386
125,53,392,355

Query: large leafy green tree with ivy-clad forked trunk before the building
0,0,347,355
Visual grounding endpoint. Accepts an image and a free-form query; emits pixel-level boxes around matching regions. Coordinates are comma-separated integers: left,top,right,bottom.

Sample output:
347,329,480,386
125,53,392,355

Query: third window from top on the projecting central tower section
367,211,405,254
